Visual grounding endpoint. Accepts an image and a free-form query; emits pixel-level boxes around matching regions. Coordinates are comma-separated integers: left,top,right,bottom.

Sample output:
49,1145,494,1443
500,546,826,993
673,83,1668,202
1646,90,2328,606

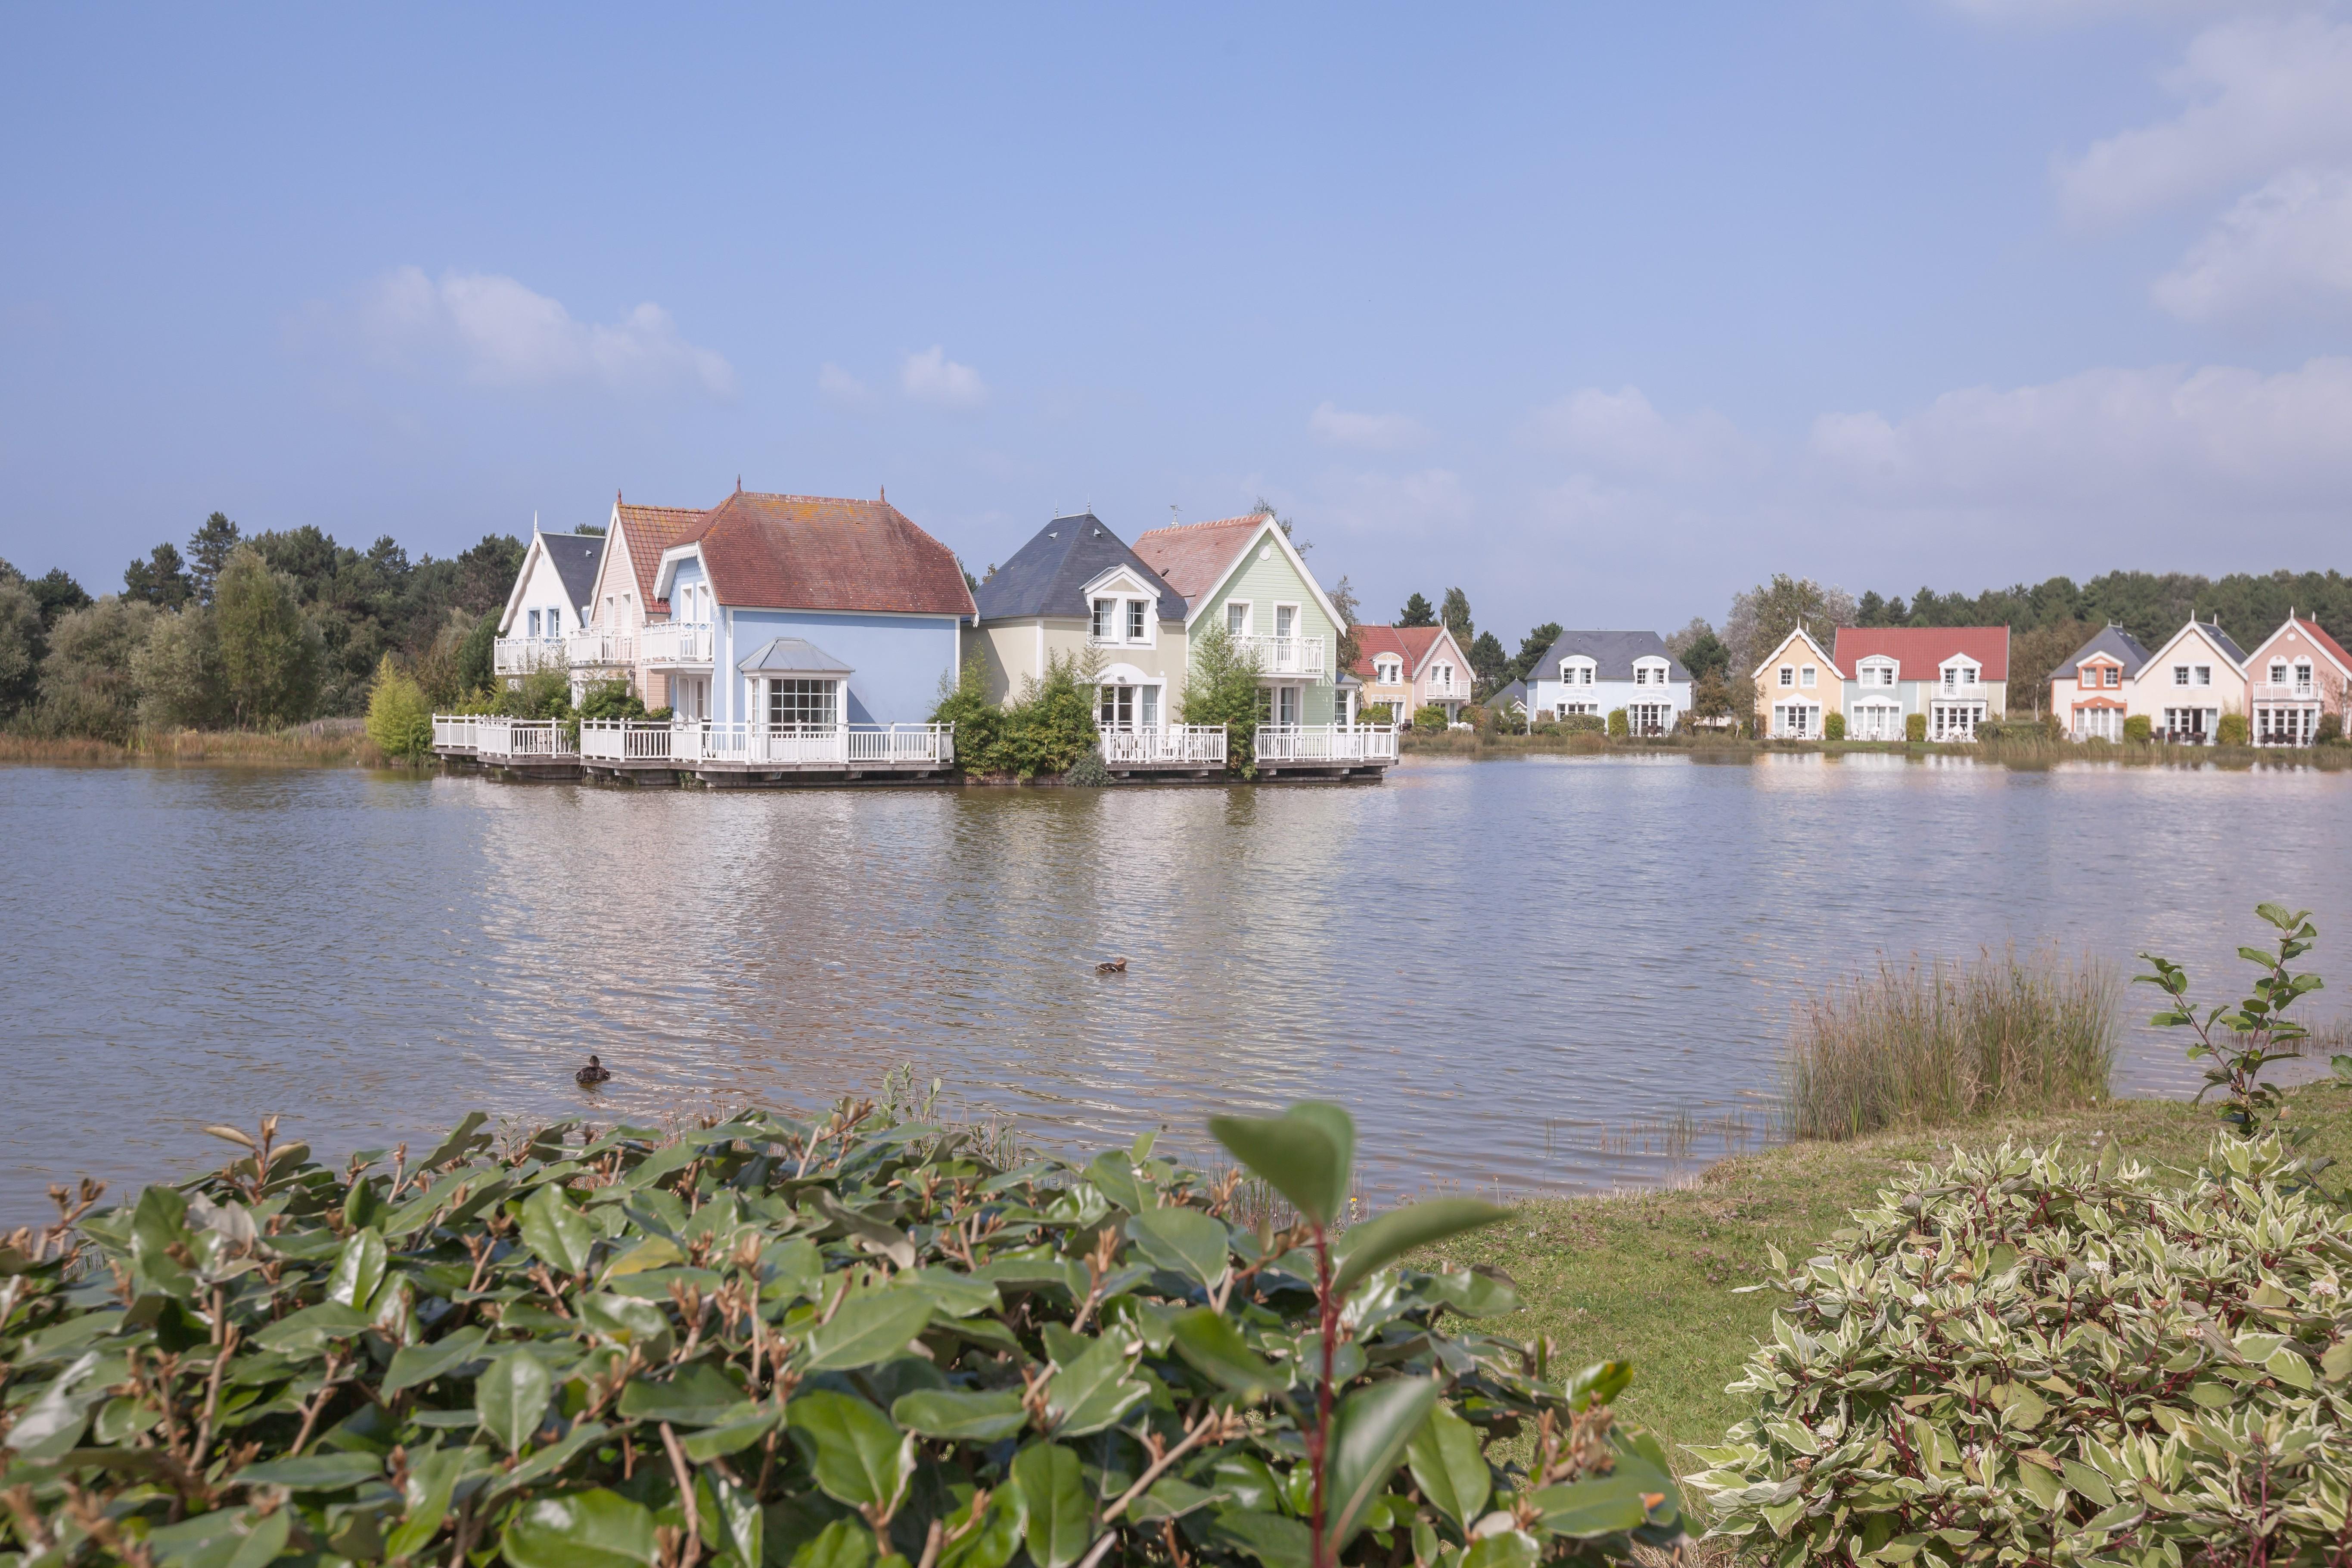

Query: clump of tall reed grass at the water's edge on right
1787,947,2122,1138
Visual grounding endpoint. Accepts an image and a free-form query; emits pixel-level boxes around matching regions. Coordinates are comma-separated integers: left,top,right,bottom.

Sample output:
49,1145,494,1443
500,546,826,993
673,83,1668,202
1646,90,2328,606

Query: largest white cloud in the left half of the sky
360,266,736,397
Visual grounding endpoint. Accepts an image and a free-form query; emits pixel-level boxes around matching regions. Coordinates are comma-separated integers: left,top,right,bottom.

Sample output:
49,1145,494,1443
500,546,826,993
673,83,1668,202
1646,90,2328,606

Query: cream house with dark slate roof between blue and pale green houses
974,512,1190,731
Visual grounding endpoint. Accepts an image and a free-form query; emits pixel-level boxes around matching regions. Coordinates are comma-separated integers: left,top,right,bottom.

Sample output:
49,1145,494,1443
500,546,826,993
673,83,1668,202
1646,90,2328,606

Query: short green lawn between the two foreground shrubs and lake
1432,1088,2352,1457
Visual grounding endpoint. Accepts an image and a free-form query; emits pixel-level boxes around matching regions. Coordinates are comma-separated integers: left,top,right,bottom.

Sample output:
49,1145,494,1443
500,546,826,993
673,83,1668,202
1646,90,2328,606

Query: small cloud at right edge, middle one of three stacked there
2152,169,2352,322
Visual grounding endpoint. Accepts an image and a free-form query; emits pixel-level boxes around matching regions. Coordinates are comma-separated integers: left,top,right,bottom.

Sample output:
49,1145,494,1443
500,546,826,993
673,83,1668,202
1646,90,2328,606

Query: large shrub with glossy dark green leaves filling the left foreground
0,1100,1679,1568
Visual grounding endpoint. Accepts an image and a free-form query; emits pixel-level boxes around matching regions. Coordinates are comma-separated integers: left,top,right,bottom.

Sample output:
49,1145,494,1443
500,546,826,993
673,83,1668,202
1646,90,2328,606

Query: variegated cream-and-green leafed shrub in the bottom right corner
1691,1136,2352,1568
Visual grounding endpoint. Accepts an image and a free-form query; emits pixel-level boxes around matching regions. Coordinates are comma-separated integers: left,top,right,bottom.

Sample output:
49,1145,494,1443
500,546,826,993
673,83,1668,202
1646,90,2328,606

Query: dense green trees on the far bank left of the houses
0,512,525,741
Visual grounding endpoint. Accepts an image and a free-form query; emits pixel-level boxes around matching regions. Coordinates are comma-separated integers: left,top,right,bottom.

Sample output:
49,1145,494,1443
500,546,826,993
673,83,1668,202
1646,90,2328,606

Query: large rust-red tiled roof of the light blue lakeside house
677,489,976,616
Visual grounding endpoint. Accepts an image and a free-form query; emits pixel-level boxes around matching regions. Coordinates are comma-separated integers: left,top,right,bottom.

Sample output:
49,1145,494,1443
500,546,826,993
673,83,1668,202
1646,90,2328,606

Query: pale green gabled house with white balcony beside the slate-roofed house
1134,512,1352,729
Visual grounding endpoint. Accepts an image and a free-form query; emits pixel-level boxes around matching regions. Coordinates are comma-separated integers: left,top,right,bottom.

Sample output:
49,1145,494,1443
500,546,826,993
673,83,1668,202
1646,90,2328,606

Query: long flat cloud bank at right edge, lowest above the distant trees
1809,360,2352,503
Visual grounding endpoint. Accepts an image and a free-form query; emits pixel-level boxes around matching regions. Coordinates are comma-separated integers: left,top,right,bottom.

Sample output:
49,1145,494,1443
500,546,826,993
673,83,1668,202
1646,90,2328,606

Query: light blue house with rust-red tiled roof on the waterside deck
640,491,976,733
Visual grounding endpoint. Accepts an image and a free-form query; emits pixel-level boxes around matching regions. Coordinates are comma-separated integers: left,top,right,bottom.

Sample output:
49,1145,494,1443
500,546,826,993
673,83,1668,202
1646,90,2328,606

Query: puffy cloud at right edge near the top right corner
2058,16,2352,221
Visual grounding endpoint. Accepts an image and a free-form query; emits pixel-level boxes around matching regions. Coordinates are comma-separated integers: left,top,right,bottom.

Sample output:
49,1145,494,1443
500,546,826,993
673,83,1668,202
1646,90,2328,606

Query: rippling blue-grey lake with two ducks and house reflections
0,755,2352,1223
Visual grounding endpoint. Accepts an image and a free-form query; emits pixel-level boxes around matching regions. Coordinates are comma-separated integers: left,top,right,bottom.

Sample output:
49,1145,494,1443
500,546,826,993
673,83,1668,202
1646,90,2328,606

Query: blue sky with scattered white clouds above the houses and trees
0,0,2352,640
